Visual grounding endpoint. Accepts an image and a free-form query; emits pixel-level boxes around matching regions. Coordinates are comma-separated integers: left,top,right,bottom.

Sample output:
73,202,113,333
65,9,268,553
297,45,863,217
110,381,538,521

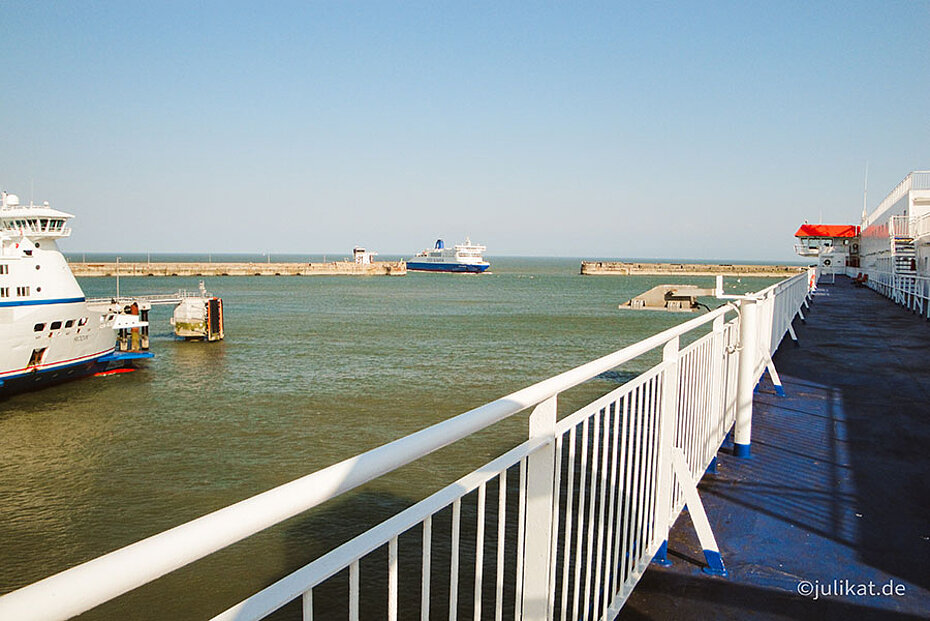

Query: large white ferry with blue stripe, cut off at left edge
0,186,152,395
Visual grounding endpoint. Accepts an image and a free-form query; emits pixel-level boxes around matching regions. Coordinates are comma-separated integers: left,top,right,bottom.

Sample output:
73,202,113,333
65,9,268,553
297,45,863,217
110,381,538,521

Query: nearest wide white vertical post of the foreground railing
518,396,557,621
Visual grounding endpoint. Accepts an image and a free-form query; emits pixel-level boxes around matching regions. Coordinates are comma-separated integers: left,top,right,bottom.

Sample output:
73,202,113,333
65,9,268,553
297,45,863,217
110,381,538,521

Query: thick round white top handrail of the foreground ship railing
0,298,748,619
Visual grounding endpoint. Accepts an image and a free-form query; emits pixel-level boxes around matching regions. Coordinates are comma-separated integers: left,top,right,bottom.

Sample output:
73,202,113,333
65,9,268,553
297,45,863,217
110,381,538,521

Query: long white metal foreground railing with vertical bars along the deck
0,272,816,621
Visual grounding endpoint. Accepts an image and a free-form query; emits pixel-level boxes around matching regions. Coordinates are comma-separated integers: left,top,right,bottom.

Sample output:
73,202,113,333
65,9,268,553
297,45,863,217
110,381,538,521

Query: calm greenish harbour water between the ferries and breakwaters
0,255,772,619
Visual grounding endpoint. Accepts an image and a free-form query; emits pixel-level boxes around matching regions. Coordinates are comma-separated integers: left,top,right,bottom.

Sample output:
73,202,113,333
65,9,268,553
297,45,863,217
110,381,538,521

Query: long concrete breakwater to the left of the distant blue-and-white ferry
69,261,407,278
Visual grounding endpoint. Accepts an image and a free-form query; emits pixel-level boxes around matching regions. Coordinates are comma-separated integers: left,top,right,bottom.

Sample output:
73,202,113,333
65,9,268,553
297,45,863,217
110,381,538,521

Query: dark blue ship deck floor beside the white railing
619,279,930,619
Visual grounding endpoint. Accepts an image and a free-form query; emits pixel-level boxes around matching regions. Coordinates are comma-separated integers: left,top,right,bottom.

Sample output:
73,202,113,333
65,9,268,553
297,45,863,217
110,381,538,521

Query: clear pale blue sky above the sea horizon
0,0,930,260
